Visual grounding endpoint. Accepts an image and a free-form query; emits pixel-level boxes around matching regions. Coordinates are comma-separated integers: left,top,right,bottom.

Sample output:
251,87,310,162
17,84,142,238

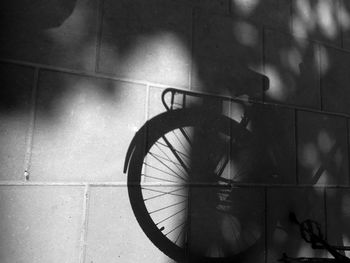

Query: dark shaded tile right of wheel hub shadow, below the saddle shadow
231,103,296,184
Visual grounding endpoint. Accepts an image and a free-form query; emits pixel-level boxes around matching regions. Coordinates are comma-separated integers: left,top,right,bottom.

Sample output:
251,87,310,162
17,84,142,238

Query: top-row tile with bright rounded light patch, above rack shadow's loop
98,0,192,87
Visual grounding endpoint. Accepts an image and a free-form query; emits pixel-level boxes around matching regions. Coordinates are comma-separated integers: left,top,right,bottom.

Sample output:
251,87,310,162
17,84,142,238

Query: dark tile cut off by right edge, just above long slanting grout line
321,48,350,114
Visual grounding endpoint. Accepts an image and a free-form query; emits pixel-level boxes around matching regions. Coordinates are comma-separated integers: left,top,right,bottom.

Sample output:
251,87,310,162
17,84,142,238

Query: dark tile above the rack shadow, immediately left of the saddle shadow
191,12,262,96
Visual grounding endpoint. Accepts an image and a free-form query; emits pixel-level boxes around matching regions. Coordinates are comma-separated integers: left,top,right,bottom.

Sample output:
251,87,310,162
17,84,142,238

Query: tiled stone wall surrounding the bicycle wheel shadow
0,0,350,263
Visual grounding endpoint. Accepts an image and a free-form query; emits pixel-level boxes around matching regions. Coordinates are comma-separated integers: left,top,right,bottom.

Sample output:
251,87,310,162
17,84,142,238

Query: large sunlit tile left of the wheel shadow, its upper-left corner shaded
30,71,146,181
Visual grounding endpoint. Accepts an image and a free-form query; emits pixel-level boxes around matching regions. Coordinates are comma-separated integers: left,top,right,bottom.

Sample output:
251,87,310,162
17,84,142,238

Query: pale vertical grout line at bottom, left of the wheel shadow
79,184,90,263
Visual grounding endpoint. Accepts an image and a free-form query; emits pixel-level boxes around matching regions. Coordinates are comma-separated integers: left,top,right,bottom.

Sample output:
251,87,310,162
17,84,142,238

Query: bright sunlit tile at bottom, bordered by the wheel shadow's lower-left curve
85,187,174,263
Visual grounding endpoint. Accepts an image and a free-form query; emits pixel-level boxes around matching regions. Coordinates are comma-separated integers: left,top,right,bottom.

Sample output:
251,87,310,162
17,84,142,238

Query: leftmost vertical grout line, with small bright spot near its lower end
23,68,40,182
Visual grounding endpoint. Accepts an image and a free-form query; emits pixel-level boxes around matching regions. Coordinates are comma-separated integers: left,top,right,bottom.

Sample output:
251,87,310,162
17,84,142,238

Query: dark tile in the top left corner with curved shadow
0,0,98,71
